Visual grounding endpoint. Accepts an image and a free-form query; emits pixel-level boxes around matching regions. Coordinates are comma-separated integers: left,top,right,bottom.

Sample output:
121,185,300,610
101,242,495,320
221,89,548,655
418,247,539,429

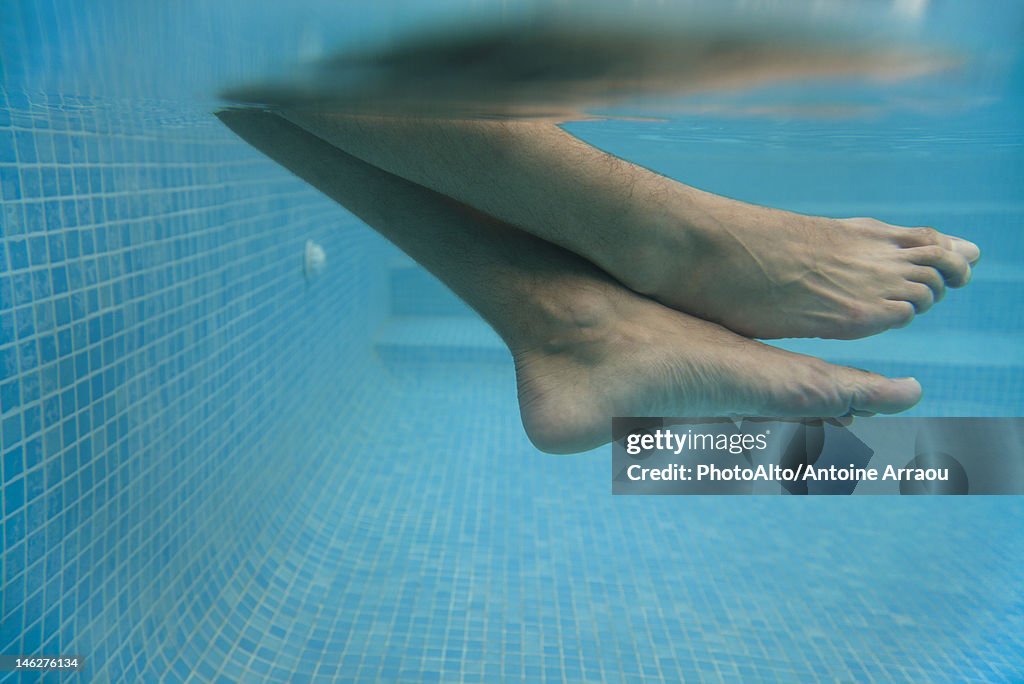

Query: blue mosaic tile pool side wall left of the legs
0,85,399,675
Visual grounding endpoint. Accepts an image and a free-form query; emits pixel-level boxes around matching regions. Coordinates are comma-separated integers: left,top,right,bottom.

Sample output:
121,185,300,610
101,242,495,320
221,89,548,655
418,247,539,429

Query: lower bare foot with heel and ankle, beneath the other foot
507,270,921,453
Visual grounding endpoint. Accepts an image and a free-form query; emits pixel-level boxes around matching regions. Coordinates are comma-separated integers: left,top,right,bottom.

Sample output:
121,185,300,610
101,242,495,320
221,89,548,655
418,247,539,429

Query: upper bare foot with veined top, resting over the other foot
620,193,980,339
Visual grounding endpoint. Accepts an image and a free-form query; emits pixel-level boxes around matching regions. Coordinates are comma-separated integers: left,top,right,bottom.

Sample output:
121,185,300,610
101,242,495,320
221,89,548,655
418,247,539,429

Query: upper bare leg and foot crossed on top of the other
284,111,979,339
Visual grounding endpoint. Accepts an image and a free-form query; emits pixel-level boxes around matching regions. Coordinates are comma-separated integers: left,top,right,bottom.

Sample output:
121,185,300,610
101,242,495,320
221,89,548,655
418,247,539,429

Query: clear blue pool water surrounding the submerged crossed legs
0,0,1024,682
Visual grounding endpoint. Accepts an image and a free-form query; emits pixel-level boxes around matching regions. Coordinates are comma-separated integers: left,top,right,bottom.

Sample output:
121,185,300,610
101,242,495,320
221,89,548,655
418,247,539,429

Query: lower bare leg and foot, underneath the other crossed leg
219,110,921,452
